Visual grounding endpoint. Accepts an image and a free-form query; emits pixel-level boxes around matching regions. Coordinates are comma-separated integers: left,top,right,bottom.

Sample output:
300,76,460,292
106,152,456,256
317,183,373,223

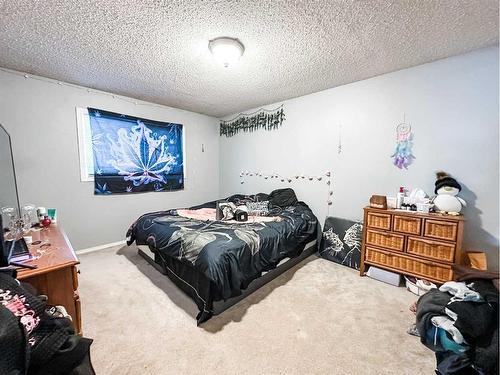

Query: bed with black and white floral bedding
127,189,318,325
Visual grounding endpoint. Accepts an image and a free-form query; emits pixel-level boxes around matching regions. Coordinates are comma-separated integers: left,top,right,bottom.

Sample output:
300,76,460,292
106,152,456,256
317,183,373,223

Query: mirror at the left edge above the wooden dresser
0,124,21,228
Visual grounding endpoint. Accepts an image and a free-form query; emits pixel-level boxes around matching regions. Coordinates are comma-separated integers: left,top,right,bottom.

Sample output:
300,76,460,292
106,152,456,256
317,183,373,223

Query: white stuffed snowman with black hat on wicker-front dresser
433,172,467,215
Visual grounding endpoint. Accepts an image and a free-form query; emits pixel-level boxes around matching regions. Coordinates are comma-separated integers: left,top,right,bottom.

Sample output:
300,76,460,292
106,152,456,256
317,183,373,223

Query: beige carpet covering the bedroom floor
80,247,434,375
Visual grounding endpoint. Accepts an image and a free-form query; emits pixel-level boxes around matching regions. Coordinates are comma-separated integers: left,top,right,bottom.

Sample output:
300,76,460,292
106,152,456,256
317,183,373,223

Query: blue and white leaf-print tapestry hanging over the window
88,108,184,195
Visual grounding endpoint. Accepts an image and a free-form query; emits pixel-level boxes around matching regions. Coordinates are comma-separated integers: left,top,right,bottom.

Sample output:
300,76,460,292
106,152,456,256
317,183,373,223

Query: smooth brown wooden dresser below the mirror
17,224,82,334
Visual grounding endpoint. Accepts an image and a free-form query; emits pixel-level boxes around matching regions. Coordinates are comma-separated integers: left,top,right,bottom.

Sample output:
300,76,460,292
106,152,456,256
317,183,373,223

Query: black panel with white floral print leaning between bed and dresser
319,217,363,270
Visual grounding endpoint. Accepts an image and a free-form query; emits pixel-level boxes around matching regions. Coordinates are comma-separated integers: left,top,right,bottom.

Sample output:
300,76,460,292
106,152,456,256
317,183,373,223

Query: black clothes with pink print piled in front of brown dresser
0,269,95,375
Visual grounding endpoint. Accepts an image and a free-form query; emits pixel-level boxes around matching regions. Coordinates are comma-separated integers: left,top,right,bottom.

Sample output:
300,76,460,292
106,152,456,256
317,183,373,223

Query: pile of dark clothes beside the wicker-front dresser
416,266,499,375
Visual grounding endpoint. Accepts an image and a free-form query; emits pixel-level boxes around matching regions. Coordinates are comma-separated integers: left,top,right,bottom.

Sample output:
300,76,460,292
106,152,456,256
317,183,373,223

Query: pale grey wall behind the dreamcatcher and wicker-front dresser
220,47,499,268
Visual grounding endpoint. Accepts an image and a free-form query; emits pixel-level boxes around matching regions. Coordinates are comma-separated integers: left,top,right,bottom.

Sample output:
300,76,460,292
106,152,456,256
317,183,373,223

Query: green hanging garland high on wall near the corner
220,106,285,137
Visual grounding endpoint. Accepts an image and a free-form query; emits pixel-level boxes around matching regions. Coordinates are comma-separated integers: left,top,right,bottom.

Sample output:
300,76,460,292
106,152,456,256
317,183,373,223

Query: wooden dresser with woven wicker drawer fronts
359,207,464,284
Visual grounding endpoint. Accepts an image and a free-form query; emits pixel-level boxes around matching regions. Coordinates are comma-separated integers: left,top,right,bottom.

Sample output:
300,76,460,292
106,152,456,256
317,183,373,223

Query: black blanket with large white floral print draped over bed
127,196,318,324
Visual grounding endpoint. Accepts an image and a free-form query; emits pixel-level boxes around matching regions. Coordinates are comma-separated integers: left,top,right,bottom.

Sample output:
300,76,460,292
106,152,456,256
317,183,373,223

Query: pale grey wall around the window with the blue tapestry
0,71,219,253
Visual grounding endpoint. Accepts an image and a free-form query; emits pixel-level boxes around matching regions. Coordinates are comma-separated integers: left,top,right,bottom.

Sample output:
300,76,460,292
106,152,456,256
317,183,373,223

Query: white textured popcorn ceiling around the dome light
0,0,498,117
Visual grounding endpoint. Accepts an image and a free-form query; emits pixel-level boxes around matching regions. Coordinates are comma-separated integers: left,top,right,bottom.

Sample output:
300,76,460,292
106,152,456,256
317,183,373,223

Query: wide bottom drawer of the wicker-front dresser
365,246,453,282
